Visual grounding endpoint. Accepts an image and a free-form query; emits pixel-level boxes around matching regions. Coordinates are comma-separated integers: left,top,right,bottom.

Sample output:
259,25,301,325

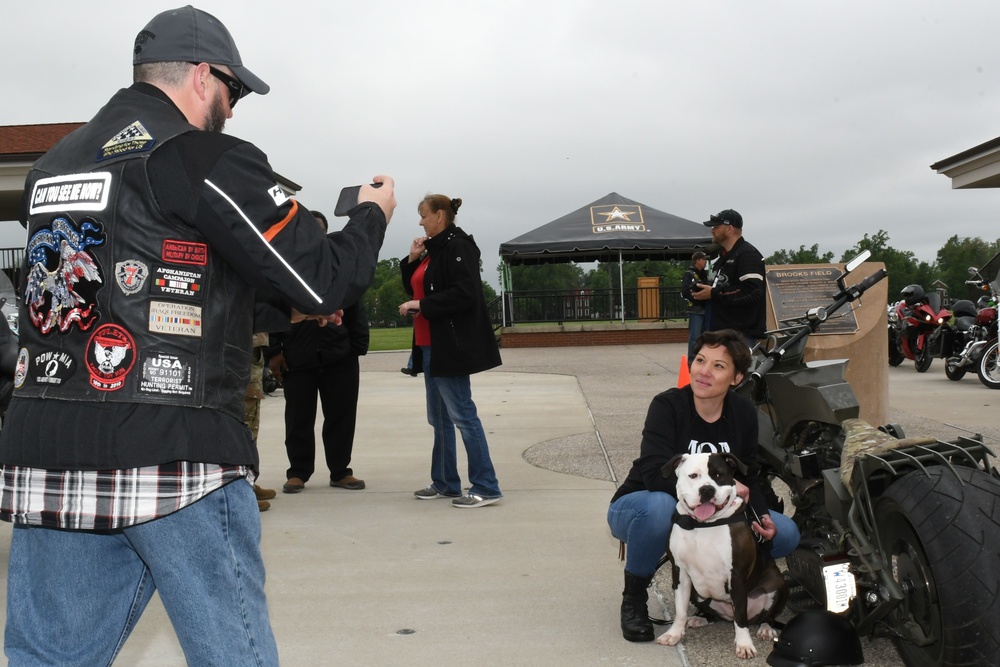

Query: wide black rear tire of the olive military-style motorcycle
875,466,1000,667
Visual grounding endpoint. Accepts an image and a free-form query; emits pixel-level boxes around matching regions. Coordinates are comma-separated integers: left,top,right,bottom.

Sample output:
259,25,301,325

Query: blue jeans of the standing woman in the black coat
421,347,501,498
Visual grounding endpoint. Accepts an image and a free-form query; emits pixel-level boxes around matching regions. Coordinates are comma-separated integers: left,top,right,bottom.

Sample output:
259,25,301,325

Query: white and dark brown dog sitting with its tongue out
656,454,788,658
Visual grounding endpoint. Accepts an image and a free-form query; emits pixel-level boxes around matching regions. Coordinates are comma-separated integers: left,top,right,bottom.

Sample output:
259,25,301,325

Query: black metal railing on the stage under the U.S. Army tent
489,286,687,328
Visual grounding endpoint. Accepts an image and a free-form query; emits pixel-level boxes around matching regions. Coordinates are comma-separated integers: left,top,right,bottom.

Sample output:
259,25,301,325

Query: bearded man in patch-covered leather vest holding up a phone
0,6,395,665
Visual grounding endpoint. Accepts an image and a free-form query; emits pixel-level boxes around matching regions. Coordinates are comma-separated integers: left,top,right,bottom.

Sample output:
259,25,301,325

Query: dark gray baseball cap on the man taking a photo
132,5,271,95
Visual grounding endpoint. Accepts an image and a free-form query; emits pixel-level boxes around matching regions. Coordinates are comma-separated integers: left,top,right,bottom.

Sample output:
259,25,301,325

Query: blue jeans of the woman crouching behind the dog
608,491,800,577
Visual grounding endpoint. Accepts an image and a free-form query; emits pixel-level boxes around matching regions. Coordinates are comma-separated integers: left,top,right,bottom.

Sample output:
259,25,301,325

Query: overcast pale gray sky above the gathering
0,0,1000,284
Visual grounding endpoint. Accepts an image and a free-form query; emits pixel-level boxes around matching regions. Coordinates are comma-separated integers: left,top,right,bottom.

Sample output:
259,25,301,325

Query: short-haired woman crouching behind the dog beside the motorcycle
608,329,799,642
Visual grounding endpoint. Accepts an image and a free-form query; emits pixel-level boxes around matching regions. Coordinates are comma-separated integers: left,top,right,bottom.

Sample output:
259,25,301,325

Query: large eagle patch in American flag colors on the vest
25,217,106,334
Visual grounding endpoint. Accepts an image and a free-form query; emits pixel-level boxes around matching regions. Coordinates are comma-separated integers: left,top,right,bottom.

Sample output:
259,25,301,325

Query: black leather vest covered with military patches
15,90,253,421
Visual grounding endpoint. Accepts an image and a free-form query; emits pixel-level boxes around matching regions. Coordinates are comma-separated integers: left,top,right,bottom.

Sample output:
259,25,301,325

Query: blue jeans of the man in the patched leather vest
4,480,278,667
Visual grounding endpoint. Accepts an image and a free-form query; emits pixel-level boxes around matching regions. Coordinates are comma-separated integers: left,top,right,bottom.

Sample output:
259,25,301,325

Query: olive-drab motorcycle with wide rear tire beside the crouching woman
739,251,1000,667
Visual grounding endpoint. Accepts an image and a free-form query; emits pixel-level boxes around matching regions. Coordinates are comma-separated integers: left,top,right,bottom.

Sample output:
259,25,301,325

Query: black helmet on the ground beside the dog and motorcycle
767,609,865,667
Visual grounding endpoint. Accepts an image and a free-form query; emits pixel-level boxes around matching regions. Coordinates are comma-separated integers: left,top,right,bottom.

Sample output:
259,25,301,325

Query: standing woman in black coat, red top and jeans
399,195,503,507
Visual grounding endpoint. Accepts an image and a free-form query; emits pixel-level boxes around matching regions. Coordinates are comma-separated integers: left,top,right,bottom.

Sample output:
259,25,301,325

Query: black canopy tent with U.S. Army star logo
500,192,712,321
